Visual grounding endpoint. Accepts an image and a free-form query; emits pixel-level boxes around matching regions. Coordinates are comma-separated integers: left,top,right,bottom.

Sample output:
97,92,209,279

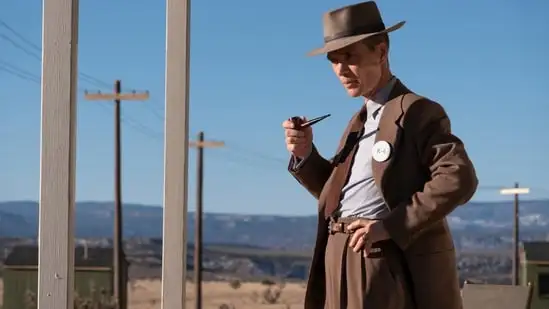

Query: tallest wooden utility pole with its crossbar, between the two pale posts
85,80,149,309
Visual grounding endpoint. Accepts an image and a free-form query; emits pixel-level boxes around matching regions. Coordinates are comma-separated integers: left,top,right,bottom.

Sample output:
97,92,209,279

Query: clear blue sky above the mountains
0,0,549,214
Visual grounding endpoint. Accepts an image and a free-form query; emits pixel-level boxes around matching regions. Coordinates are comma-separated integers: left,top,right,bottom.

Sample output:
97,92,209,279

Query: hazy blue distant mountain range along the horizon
0,200,549,249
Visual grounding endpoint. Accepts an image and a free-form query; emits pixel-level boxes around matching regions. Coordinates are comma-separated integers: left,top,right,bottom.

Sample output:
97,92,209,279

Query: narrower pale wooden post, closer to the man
162,0,190,309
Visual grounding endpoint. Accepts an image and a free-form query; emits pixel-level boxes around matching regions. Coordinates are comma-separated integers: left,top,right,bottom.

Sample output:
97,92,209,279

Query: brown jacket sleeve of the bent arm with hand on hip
383,102,478,250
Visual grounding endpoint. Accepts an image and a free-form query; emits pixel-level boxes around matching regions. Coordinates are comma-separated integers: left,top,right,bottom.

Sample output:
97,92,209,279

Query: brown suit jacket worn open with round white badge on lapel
290,81,478,309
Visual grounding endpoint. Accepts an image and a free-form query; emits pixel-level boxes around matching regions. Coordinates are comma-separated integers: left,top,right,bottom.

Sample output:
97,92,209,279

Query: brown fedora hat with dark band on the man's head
307,1,405,56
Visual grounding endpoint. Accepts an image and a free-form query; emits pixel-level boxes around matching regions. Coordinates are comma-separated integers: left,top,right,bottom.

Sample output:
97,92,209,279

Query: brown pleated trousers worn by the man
324,218,415,309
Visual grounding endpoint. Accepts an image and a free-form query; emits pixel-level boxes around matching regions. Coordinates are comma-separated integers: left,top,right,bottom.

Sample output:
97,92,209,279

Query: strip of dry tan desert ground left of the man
0,280,305,309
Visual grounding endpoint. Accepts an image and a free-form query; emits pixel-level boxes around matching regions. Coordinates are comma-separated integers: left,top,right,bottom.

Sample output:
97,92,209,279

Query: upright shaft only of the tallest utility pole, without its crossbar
113,80,124,309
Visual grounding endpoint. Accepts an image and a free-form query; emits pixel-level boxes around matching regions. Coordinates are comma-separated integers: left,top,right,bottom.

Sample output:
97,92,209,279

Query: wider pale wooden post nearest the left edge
37,0,78,309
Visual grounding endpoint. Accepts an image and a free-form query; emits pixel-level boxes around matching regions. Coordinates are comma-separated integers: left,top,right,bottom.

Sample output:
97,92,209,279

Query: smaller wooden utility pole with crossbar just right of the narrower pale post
189,132,220,309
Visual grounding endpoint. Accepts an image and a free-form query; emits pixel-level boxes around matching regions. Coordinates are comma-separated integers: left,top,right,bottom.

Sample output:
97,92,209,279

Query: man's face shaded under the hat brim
327,42,387,98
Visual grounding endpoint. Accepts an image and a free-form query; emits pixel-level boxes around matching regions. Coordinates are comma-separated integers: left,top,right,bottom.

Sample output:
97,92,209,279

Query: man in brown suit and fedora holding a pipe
283,1,478,309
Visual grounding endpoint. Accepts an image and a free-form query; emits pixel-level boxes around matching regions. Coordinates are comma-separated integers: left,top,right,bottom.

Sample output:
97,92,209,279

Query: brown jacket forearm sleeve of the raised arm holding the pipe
288,145,332,199
